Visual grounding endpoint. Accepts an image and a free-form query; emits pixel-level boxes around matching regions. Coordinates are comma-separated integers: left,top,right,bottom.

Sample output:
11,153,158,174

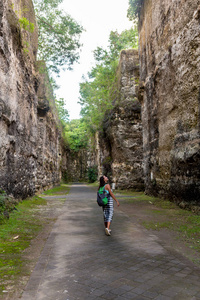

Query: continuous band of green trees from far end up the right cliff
56,28,138,156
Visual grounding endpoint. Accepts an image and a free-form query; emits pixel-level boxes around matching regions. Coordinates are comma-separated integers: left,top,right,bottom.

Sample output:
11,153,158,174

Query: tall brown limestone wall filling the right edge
139,0,200,201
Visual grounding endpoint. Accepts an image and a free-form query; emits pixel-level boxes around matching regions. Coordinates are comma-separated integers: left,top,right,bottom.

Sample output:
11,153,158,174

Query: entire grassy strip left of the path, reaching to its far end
0,184,69,299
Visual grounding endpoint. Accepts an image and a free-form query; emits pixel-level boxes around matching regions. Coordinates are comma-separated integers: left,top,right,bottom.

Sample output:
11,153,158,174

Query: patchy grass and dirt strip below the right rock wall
116,190,200,252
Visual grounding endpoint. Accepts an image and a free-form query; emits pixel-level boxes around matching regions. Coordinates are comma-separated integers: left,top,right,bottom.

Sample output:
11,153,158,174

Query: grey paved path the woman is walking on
21,184,200,300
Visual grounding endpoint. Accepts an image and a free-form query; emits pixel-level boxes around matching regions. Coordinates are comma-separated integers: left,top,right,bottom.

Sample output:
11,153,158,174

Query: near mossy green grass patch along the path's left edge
0,196,46,295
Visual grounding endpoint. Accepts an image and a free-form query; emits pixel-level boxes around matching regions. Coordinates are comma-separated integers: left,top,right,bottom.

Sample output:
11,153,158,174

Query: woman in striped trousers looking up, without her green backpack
99,176,119,235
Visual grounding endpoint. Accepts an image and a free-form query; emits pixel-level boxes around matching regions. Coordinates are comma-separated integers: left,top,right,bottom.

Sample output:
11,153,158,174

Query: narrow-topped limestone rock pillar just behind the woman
101,50,144,190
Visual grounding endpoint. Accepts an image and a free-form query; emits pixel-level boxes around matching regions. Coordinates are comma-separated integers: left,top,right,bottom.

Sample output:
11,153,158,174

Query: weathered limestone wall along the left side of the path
0,0,61,198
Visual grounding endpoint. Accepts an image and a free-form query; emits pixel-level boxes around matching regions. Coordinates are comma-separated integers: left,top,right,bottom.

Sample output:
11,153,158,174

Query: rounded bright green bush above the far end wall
65,119,88,152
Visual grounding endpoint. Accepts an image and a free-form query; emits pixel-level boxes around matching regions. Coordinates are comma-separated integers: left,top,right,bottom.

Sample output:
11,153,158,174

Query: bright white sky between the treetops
56,0,133,120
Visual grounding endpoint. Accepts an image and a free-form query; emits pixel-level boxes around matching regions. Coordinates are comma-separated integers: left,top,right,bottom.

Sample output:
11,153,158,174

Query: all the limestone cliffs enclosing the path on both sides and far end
0,0,200,203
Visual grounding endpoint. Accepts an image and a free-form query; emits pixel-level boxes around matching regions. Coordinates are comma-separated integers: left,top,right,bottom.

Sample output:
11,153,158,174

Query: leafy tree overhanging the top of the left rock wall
33,0,83,74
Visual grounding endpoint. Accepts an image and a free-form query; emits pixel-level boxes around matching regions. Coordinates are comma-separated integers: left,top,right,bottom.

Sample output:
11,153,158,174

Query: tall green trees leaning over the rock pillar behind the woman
80,28,138,133
